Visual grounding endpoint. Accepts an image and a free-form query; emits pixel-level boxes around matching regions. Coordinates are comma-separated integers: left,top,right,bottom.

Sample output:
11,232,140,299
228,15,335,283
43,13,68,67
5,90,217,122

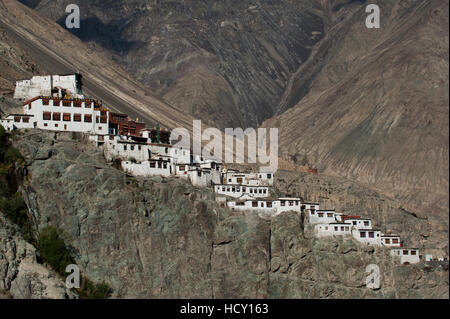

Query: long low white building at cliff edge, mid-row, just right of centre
227,198,300,216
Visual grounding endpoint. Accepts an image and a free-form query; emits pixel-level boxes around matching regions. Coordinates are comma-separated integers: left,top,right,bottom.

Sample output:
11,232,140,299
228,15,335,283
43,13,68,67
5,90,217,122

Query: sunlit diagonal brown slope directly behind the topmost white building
0,0,192,128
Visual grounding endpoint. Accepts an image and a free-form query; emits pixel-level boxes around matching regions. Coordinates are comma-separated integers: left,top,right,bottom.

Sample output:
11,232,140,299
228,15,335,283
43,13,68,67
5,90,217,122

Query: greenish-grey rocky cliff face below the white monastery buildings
1,132,448,298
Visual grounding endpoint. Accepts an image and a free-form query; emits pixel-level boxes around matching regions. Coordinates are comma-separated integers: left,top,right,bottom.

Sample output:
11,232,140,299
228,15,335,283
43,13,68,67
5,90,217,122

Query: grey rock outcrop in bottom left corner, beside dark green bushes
0,213,77,299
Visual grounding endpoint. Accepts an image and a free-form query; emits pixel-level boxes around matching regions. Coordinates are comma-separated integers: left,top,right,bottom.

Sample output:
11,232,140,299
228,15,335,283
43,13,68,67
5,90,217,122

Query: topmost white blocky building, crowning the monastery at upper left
14,74,84,100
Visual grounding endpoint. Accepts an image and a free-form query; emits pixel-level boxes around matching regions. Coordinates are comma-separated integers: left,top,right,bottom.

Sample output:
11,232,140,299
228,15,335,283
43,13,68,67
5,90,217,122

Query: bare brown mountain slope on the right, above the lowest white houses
263,0,449,218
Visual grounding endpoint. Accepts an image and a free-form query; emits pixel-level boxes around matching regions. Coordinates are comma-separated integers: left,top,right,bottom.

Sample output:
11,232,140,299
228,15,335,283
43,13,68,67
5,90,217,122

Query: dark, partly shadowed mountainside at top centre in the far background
23,0,324,128
